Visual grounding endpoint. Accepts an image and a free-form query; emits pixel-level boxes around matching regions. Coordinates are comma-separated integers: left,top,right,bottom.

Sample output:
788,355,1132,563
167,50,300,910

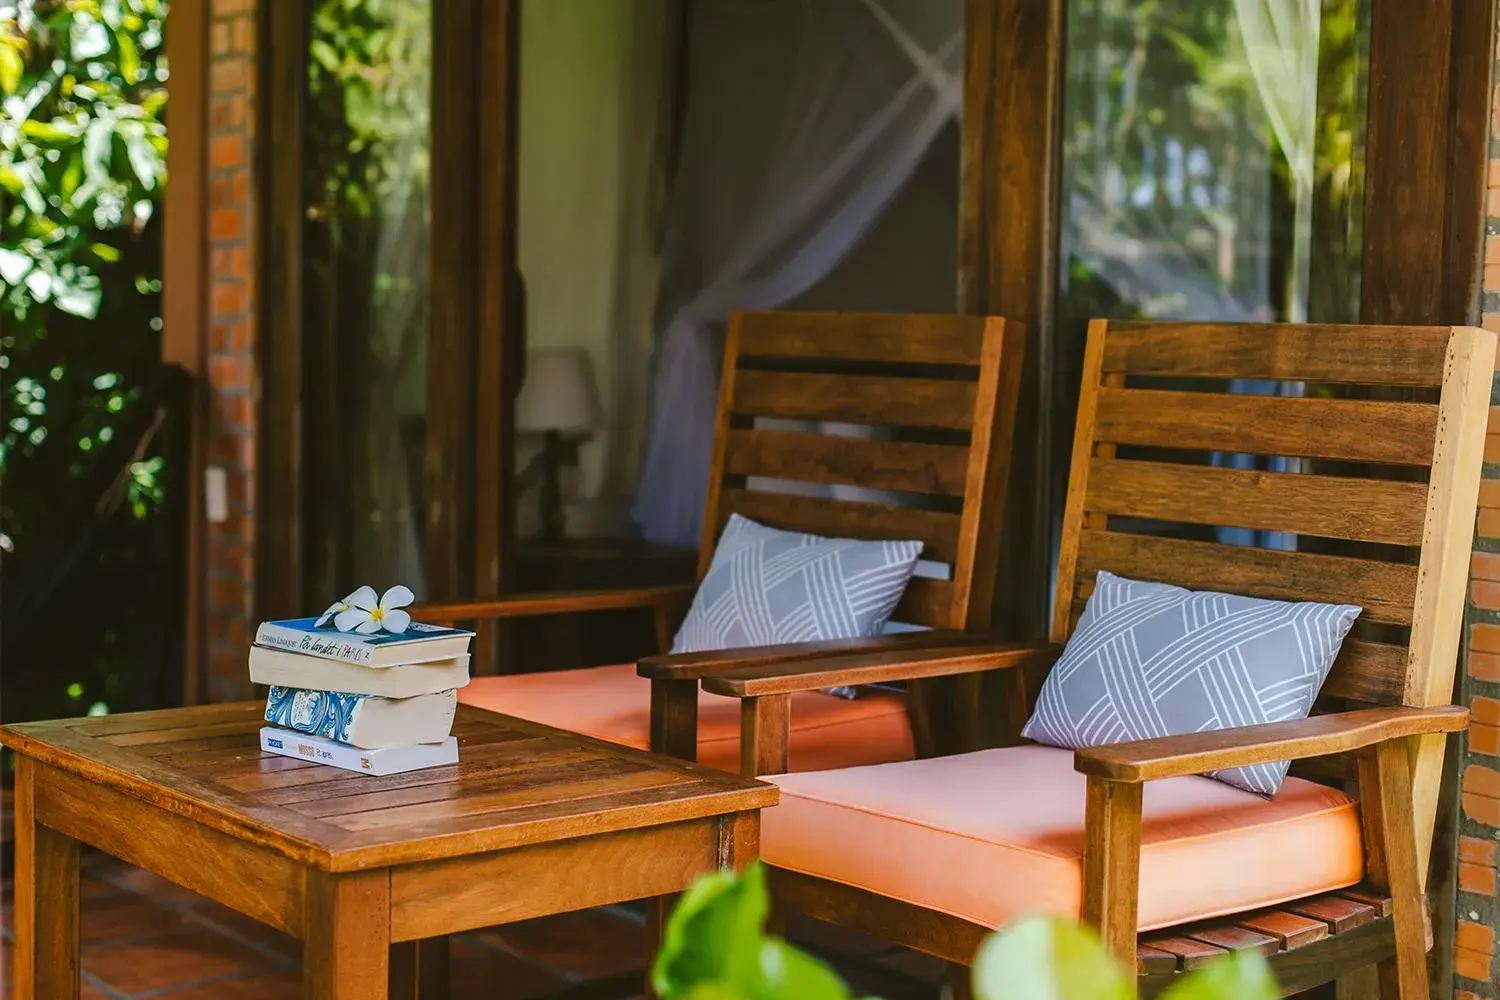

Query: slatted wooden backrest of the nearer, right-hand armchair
1052,321,1496,870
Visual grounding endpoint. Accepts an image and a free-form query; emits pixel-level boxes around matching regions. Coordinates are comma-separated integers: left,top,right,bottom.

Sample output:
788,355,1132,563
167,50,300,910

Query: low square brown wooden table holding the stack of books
0,703,777,1000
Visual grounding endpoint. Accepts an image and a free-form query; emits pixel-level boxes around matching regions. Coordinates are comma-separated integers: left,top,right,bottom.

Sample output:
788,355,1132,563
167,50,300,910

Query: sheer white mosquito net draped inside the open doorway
632,0,963,547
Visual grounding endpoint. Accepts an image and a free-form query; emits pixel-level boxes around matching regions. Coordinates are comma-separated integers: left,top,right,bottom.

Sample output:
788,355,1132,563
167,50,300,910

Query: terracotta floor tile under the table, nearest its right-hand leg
480,909,645,979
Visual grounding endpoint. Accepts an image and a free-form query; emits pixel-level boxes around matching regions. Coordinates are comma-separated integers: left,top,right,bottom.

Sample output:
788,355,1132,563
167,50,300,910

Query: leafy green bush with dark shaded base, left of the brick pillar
0,0,182,720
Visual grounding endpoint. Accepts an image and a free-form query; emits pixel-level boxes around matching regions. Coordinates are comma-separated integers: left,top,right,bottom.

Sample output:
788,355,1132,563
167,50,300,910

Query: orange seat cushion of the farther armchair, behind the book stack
459,664,912,771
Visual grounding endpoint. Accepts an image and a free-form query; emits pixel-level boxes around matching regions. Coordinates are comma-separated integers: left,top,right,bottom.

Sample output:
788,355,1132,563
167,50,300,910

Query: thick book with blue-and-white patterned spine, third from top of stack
266,687,458,750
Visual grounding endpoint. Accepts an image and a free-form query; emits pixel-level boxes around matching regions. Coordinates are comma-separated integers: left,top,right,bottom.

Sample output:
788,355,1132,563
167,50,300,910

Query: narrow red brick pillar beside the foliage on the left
204,0,258,702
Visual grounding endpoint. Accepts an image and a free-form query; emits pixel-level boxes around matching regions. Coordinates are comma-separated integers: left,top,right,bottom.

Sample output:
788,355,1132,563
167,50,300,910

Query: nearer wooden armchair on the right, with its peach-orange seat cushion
660,322,1496,1000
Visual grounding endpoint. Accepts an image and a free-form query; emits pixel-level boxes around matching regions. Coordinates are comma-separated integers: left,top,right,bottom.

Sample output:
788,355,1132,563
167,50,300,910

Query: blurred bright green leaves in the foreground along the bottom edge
653,865,1277,1000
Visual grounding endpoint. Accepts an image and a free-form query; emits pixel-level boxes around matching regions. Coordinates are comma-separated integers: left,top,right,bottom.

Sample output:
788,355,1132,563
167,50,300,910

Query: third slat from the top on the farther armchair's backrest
725,430,969,496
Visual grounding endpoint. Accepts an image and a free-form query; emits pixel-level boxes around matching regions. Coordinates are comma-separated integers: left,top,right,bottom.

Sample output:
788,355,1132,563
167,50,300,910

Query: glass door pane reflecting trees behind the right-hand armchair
1052,0,1370,554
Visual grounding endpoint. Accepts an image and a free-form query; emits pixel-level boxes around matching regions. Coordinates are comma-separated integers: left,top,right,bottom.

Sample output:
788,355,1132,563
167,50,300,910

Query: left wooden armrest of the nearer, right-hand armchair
704,640,1062,699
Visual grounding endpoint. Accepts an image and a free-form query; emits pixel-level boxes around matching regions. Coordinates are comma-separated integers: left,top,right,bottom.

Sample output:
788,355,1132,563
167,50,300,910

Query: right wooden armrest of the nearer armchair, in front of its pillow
1073,705,1469,784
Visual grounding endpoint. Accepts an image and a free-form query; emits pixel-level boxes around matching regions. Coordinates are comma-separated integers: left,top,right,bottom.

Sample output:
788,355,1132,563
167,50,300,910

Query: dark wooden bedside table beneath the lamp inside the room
513,538,698,673
